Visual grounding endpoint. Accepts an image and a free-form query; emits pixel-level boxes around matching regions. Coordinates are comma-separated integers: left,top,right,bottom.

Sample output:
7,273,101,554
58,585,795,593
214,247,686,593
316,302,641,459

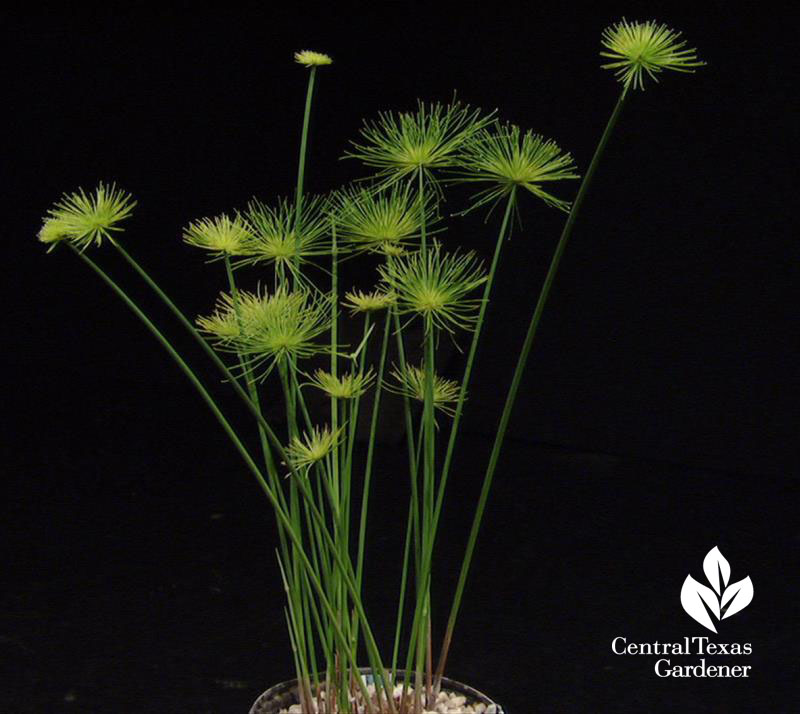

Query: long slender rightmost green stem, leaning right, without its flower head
436,83,627,683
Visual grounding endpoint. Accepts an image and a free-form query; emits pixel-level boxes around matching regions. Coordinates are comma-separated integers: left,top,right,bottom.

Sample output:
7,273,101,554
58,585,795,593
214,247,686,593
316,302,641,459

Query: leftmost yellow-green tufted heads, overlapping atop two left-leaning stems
38,182,136,251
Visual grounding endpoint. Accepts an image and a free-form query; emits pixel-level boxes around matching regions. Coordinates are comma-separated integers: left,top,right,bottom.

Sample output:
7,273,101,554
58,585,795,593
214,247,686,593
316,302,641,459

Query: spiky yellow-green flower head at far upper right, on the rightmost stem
600,19,706,90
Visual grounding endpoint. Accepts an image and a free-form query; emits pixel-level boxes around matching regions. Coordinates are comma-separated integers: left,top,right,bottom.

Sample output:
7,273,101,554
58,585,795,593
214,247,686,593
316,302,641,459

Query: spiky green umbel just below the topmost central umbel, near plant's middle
332,184,436,255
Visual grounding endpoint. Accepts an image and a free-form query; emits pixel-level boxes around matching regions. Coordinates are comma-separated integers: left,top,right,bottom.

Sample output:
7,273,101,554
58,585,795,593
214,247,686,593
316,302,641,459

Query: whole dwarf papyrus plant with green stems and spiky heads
39,21,702,714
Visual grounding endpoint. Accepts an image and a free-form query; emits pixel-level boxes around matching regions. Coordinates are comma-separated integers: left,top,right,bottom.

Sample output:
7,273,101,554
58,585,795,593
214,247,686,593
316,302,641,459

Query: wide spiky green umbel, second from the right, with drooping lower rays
454,124,579,211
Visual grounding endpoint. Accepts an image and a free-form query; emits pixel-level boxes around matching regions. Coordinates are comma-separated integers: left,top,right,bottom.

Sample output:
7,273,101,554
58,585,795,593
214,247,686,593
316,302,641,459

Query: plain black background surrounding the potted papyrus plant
0,2,798,714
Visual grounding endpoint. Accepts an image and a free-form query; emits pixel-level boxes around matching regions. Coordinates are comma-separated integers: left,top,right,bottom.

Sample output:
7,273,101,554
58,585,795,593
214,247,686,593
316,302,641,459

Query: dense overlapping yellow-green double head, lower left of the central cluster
197,288,330,377
